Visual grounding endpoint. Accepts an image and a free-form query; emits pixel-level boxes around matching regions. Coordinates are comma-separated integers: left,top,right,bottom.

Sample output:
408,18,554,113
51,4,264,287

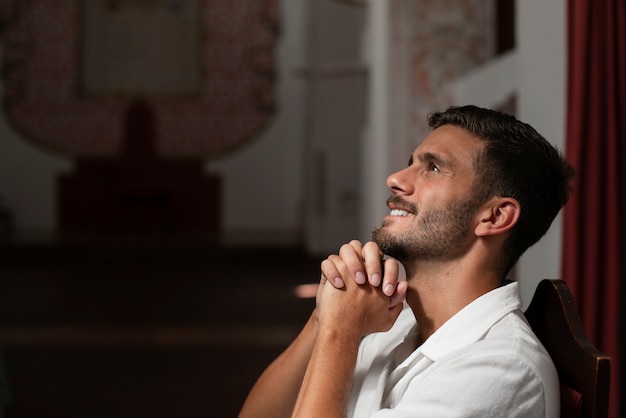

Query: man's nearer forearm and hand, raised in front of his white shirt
293,246,406,418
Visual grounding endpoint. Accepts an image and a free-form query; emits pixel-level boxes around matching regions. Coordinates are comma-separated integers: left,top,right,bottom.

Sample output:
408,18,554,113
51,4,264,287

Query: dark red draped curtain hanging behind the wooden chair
562,0,626,418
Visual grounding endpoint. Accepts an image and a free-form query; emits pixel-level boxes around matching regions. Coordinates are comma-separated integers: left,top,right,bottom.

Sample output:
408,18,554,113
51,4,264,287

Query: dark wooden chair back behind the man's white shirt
525,279,611,418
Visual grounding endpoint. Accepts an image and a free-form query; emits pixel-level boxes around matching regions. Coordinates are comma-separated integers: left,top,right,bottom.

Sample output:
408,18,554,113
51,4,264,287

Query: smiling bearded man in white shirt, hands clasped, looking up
240,106,573,418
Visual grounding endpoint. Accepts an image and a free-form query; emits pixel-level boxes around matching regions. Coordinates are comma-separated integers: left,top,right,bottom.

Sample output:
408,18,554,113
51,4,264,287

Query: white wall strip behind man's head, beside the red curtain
516,0,566,304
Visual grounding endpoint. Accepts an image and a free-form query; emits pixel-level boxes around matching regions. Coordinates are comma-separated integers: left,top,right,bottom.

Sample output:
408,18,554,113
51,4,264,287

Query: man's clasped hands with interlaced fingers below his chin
316,240,407,336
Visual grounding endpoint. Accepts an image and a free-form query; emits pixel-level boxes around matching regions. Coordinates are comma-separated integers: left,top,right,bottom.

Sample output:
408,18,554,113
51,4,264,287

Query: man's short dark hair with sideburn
428,105,574,277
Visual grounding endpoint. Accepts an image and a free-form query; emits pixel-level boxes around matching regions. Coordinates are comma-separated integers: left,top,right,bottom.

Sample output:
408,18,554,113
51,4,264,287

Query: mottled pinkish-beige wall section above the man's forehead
390,0,496,152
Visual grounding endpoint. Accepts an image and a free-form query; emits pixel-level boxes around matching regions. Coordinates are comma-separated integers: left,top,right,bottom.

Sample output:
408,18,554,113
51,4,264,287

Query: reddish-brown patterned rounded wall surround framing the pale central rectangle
0,0,278,158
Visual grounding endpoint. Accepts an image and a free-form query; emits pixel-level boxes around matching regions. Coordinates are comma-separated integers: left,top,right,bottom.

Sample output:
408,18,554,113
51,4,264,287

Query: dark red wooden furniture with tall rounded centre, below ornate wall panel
58,103,221,239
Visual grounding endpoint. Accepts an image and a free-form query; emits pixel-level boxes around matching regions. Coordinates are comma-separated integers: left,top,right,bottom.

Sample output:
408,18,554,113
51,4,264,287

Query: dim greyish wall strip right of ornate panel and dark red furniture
209,0,307,247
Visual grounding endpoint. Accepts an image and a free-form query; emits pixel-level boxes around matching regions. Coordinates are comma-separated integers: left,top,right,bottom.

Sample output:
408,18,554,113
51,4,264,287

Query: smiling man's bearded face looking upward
372,125,484,262
